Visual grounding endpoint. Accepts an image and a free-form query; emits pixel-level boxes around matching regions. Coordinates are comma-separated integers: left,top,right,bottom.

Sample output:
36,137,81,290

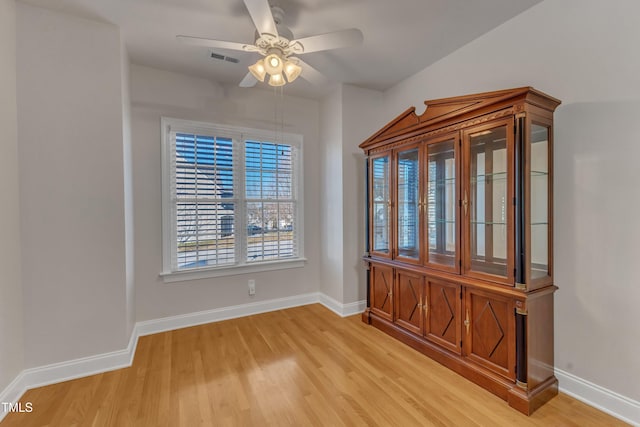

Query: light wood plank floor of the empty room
0,304,625,427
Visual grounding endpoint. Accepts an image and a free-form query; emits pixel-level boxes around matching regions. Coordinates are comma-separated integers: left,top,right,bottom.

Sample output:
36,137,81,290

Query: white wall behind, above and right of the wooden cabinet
386,0,640,401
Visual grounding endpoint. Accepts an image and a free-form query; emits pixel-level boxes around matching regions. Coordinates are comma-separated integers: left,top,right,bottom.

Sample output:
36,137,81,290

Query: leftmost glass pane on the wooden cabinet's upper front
371,156,391,253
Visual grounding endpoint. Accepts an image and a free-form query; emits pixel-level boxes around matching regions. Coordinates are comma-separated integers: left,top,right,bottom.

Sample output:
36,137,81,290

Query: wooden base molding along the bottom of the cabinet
362,309,558,415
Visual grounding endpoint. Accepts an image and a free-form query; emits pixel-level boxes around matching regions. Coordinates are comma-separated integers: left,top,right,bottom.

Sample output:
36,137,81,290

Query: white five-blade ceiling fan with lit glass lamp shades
176,0,363,87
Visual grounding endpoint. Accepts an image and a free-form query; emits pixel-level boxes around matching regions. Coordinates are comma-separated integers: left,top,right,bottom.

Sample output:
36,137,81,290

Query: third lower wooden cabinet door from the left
424,278,462,354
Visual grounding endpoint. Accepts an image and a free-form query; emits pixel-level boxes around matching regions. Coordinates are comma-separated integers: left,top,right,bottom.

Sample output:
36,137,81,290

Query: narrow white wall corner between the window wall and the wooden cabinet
320,85,384,304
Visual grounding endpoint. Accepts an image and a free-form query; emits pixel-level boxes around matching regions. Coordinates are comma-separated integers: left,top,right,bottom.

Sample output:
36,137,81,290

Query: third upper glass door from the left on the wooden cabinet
426,140,457,266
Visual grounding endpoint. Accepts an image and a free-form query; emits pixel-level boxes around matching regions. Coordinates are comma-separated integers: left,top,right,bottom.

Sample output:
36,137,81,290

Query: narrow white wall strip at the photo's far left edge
0,0,23,395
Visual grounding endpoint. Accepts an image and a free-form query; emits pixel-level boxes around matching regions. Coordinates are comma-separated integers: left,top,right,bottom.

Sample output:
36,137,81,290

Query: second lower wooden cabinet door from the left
394,270,424,335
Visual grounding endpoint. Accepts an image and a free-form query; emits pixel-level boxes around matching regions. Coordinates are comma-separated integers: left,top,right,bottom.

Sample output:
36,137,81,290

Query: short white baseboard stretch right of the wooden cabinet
555,368,640,426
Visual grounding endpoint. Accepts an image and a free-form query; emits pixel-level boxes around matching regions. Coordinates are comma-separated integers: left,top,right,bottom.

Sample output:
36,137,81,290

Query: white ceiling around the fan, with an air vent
21,0,541,97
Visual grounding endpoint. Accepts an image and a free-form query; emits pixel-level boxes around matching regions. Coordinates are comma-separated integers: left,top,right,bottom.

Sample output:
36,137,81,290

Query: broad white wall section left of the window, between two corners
17,2,129,368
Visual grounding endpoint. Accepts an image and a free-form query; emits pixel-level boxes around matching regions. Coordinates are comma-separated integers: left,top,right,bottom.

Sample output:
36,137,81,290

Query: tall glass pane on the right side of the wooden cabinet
529,124,549,279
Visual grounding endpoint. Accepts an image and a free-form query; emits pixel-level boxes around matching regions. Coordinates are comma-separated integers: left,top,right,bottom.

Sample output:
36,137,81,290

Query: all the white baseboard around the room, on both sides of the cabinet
7,298,640,426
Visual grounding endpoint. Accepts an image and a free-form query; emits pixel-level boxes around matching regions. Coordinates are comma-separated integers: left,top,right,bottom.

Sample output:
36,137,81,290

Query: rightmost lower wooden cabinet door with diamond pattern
463,289,516,380
